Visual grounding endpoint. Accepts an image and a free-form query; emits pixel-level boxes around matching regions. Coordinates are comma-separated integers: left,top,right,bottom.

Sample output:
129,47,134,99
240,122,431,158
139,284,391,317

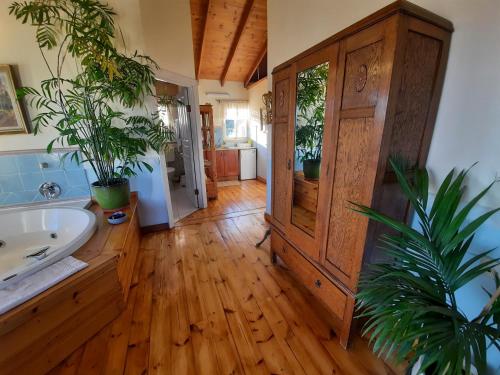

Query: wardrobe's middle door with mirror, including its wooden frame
286,44,338,261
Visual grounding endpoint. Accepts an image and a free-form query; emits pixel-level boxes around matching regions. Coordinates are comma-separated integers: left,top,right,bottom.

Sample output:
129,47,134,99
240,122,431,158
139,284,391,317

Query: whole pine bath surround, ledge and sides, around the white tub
0,193,141,374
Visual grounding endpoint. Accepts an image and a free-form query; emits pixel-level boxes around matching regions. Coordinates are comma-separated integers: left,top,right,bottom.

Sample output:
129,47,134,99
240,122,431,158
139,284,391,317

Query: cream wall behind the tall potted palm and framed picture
0,0,194,226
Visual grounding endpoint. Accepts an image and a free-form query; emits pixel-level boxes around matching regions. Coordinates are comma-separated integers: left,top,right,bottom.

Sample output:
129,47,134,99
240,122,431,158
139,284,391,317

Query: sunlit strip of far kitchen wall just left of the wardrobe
248,78,269,180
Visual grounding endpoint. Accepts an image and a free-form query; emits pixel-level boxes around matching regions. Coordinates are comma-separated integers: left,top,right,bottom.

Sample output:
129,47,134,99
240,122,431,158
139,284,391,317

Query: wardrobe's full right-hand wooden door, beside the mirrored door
323,19,396,291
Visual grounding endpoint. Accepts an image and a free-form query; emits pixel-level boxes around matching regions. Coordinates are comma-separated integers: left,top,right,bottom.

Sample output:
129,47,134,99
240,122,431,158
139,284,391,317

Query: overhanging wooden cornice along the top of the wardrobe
274,0,454,74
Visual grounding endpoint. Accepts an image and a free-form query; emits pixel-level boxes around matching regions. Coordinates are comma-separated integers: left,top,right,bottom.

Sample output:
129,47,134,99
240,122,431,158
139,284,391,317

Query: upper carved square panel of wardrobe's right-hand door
342,41,383,109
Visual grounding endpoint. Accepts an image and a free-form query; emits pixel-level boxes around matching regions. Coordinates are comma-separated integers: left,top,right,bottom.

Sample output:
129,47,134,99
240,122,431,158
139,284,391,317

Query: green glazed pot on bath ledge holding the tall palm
91,178,130,210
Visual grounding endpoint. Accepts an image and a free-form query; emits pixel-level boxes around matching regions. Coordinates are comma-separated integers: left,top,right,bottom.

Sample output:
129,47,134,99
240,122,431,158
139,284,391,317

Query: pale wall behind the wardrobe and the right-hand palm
268,0,500,371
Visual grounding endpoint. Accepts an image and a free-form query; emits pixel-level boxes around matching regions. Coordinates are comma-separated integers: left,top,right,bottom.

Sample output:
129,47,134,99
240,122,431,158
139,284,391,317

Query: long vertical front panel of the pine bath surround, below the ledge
0,259,123,374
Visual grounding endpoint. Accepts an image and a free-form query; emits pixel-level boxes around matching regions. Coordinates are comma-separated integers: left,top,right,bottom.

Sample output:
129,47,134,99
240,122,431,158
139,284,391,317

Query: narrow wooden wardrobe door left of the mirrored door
271,68,291,231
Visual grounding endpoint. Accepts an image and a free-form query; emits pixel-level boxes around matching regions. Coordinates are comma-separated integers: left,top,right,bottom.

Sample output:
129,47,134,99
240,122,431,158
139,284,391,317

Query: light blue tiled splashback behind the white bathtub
0,152,90,207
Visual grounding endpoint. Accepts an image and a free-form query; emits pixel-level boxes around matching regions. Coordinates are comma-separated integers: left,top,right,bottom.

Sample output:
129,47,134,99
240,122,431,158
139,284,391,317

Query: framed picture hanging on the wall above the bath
0,65,28,134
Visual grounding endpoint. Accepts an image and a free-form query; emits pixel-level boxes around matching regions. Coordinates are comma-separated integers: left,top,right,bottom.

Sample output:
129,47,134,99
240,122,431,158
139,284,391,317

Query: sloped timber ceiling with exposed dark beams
190,0,267,86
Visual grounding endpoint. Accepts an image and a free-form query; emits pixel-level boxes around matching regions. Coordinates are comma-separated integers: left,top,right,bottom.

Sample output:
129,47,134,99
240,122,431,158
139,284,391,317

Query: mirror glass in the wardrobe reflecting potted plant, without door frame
292,62,328,236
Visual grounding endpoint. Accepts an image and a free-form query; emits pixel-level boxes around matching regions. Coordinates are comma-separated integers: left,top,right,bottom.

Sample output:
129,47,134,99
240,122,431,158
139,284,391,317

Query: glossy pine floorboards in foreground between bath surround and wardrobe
47,184,393,375
